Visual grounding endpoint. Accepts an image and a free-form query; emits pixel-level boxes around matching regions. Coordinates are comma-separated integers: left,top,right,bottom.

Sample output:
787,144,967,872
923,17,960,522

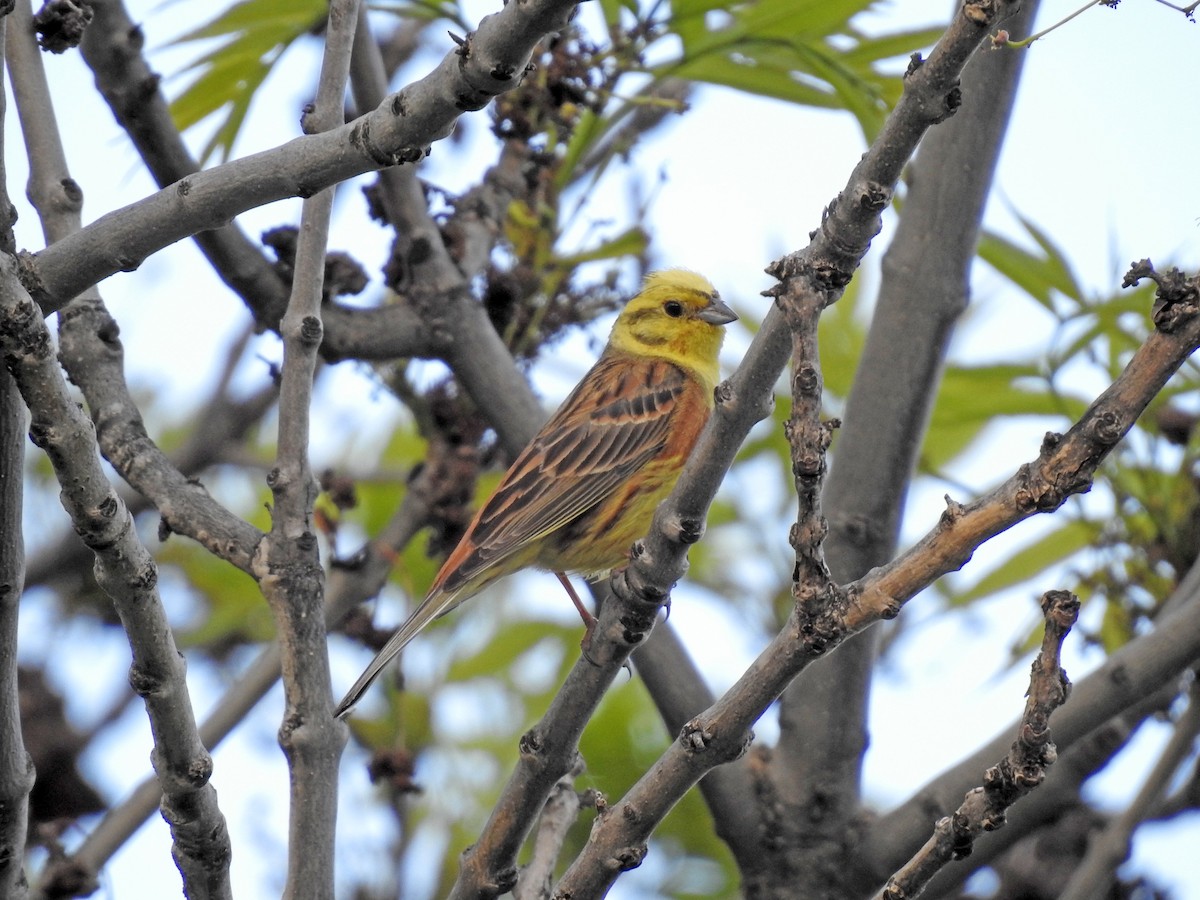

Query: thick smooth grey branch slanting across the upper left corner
23,0,585,312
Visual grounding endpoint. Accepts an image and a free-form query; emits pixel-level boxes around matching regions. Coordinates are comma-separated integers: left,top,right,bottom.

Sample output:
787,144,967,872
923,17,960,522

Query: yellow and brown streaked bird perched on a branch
334,269,738,719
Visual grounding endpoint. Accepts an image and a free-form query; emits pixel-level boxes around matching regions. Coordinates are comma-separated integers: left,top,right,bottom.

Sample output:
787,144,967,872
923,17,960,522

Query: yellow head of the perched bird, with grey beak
608,269,737,391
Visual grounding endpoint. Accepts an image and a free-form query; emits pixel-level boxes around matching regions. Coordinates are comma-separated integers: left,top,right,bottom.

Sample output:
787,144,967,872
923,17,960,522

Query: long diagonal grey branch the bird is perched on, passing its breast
434,4,1022,896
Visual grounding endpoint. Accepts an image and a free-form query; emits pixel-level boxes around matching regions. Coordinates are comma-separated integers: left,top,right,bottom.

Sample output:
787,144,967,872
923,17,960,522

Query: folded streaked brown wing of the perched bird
443,356,686,589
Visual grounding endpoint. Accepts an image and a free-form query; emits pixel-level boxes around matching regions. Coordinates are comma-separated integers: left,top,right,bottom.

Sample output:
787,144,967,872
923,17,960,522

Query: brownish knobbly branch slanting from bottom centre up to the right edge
558,263,1200,896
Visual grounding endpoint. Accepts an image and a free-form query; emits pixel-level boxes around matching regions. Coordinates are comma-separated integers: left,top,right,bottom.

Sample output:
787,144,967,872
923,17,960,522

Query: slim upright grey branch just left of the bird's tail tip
253,0,359,898
